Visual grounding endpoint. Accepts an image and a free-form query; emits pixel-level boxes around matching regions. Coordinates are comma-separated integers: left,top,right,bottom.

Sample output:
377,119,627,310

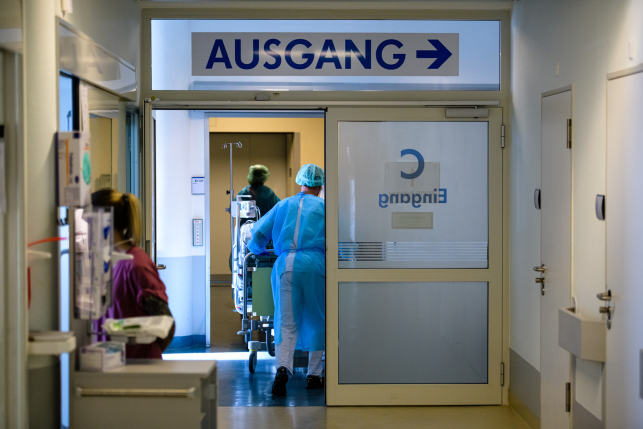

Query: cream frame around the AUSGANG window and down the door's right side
140,1,511,404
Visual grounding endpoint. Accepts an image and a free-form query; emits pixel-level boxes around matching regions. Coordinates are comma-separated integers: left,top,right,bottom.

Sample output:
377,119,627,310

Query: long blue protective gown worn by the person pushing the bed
248,192,326,352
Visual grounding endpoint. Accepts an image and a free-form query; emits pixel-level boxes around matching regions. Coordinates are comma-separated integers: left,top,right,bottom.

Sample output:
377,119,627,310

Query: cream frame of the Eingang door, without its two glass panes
326,108,504,406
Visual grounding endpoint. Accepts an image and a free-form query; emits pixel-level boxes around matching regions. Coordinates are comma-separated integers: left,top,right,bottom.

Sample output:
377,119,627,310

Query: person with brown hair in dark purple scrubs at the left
92,189,176,359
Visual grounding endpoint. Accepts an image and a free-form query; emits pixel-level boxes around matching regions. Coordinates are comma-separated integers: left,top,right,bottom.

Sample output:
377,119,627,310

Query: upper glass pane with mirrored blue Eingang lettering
338,122,489,268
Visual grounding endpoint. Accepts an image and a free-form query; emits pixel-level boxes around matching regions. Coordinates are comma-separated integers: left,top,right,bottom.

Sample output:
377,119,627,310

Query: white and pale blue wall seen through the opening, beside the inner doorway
156,110,209,337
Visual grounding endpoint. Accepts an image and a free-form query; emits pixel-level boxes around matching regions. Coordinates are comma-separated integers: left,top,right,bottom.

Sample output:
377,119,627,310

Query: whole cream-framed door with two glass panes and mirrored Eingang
326,108,502,405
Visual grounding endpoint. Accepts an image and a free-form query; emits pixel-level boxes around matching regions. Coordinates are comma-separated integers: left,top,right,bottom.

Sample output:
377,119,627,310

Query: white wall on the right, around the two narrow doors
511,0,643,419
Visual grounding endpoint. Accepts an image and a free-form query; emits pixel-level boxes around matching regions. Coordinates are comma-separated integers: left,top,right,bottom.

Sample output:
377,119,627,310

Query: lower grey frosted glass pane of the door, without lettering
339,282,488,384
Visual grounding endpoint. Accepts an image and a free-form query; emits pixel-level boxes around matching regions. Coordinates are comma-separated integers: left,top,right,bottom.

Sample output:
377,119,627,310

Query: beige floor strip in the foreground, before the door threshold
218,406,529,429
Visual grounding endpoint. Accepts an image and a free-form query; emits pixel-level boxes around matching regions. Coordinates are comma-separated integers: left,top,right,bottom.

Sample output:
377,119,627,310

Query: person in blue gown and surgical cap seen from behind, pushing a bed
248,164,326,396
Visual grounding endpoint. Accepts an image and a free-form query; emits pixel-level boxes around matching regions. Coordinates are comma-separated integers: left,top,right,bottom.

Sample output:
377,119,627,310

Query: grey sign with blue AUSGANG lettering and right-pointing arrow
192,33,459,76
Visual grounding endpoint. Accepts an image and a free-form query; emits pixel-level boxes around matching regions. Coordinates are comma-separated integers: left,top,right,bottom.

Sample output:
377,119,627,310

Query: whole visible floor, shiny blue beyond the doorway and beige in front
169,348,529,429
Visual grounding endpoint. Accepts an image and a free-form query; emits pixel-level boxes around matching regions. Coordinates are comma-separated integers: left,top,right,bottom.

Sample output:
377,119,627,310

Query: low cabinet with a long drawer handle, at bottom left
70,360,217,429
